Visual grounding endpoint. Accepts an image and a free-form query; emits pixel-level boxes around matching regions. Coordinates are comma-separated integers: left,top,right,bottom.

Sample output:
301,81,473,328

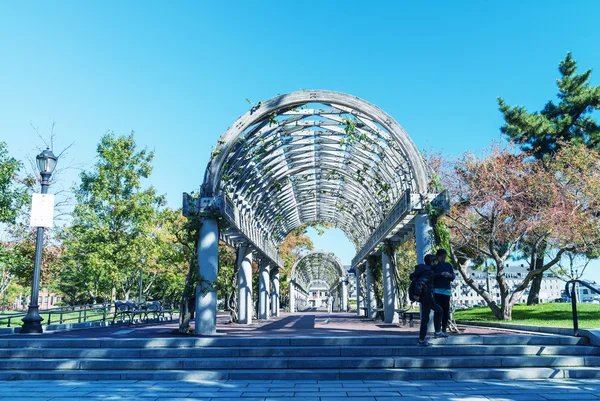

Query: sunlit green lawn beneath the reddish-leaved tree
454,303,600,329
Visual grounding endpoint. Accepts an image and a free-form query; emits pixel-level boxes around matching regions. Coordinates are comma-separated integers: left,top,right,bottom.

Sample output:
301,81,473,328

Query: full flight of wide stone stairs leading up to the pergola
0,335,600,380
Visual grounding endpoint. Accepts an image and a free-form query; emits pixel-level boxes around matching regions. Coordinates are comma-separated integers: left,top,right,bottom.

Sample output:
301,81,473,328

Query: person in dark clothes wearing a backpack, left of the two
409,255,448,347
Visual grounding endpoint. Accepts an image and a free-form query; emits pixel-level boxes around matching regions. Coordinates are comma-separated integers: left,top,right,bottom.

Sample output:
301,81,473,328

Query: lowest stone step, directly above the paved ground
0,367,600,381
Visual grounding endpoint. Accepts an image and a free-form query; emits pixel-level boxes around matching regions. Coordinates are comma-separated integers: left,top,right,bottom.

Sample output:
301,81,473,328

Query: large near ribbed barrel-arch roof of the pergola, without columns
203,91,427,255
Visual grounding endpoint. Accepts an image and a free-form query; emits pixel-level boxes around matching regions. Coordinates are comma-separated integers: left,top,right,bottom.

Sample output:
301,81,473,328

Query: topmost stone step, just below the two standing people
0,335,589,348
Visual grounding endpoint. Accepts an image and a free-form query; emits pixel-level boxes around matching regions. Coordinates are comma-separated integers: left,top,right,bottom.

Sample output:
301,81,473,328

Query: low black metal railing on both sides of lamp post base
0,303,113,328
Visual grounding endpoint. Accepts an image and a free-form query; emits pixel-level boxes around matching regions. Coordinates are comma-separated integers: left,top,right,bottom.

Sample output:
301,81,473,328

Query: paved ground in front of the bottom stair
0,380,600,401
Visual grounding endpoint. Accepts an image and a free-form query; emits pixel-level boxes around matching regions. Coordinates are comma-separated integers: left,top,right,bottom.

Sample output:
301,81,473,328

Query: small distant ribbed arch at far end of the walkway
290,251,346,291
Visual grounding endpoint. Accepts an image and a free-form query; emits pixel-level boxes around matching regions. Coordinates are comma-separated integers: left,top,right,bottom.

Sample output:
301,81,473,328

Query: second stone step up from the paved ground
0,356,600,371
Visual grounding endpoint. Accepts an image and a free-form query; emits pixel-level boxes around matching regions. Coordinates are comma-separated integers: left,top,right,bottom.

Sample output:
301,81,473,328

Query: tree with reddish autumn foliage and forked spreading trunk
444,145,600,320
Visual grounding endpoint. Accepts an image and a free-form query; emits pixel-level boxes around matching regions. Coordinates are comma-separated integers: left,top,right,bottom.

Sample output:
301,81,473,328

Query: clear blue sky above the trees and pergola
0,0,600,281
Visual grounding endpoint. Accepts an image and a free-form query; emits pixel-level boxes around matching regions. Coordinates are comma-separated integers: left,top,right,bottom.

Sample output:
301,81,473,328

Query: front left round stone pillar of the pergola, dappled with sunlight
194,218,219,335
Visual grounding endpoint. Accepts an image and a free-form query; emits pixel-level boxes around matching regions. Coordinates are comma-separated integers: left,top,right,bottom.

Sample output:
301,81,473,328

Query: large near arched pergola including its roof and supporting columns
184,91,448,334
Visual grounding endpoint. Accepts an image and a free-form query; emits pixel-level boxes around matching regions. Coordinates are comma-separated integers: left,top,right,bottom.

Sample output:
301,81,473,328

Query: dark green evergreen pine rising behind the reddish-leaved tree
498,53,600,305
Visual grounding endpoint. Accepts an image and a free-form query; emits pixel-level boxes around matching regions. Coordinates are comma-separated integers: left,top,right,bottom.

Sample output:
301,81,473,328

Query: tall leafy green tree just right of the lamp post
64,132,164,301
